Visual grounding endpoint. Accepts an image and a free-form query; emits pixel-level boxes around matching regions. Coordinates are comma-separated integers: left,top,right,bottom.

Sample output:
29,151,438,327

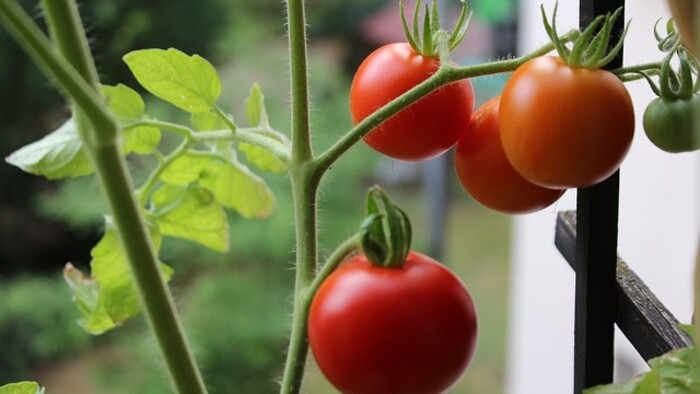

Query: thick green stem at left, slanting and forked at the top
0,0,206,394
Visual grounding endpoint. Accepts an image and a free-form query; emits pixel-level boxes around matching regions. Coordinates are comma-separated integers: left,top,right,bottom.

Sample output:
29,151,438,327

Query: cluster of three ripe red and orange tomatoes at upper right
350,49,634,214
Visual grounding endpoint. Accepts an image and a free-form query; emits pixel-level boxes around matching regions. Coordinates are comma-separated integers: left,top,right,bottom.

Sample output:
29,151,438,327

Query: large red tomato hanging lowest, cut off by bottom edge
308,252,477,394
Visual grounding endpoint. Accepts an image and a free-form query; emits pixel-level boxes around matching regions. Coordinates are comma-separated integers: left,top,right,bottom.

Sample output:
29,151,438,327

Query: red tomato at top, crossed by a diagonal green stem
350,43,474,160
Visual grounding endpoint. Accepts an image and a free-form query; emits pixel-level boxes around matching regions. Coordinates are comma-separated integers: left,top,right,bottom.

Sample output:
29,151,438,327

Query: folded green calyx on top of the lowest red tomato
360,186,412,268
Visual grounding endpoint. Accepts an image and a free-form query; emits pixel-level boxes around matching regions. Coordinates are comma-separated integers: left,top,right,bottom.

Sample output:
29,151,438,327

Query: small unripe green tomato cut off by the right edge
642,93,700,153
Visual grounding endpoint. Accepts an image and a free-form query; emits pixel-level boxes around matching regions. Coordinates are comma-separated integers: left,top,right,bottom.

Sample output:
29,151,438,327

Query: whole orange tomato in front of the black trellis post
499,56,634,189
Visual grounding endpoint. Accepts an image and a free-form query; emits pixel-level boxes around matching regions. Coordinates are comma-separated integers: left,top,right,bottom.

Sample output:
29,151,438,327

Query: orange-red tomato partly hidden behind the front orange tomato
455,97,564,214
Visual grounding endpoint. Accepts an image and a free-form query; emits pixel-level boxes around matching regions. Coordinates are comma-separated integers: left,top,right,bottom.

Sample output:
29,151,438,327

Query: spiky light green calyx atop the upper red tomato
399,0,472,59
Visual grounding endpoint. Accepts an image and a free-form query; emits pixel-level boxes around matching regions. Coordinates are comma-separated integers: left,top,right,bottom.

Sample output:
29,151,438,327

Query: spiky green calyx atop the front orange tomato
540,3,629,69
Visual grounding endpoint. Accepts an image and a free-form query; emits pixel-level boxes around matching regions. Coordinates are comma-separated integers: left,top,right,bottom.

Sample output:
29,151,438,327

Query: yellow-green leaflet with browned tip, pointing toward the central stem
199,158,276,218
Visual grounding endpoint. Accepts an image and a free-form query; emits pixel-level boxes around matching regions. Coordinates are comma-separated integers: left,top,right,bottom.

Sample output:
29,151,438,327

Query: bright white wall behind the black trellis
506,0,700,394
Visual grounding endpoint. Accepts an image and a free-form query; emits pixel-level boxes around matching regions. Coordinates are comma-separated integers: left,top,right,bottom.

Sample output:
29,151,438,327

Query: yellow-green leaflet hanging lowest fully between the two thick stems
153,184,229,252
